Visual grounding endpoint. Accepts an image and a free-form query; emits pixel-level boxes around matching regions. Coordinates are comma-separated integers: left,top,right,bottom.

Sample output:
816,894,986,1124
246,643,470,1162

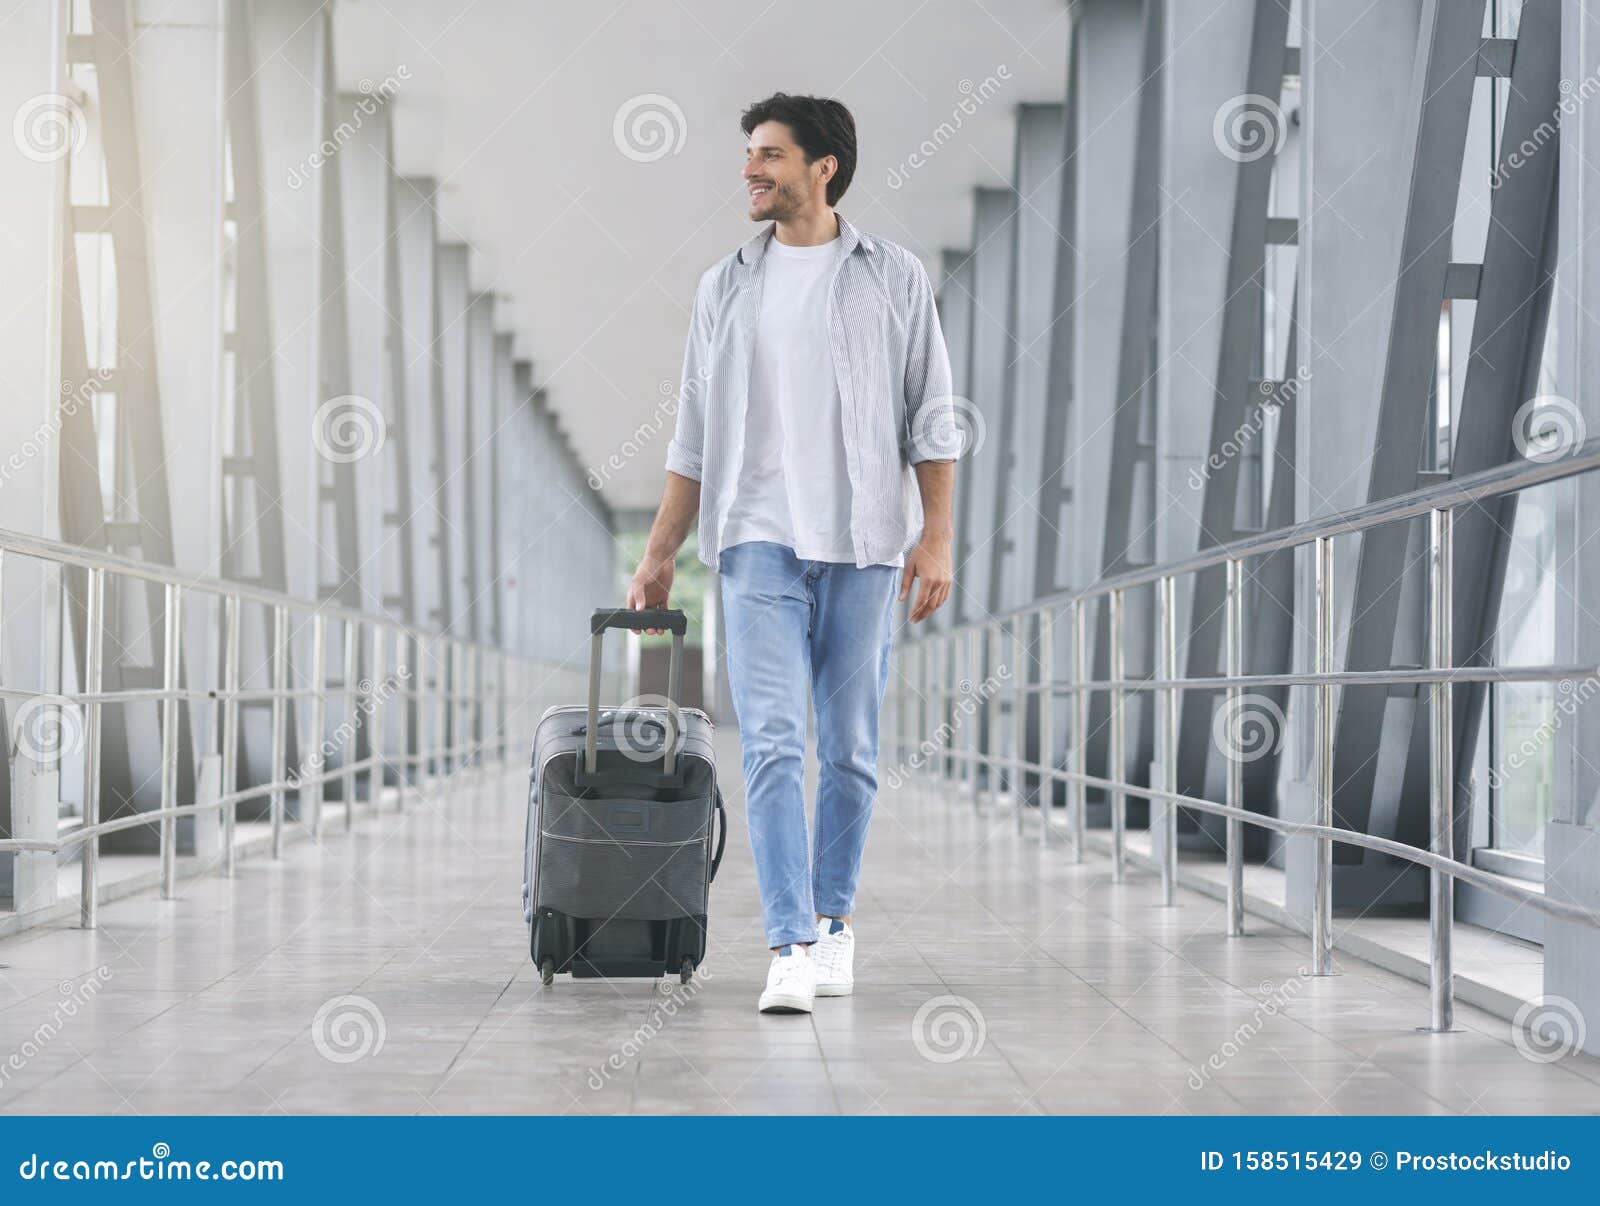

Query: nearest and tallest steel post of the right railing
1427,507,1456,1032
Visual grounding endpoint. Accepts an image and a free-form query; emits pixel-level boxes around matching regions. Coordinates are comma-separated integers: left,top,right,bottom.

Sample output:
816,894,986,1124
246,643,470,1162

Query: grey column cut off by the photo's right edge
1544,0,1600,1054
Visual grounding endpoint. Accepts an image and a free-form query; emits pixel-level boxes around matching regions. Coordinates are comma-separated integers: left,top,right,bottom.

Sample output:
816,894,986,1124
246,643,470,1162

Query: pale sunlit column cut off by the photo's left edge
0,0,66,912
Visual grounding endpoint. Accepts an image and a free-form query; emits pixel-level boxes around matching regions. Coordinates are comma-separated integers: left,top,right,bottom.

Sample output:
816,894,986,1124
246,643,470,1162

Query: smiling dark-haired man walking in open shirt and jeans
627,93,957,1012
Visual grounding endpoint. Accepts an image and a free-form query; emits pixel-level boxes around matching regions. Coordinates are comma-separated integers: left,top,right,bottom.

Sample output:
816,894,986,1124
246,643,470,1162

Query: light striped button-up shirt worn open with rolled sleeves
667,218,960,569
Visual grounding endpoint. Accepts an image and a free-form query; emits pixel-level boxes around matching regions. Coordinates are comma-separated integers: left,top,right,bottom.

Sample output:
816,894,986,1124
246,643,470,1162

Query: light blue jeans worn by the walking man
720,541,901,947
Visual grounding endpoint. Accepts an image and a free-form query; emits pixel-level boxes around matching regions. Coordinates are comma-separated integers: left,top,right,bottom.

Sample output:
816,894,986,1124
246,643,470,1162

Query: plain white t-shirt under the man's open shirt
723,237,902,565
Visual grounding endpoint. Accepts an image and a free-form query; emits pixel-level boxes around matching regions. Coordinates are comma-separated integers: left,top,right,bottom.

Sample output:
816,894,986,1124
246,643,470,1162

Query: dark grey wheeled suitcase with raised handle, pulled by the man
522,608,728,984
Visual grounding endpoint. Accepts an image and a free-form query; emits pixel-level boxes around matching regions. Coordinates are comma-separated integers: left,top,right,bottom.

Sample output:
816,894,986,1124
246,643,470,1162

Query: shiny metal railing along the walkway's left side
0,529,595,928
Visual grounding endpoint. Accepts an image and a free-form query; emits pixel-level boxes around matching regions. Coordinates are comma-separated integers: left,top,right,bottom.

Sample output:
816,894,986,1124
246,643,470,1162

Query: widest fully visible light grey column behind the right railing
1269,0,1421,916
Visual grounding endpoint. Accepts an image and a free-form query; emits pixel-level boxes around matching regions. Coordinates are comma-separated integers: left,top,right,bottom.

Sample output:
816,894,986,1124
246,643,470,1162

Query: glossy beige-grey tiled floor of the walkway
0,739,1600,1113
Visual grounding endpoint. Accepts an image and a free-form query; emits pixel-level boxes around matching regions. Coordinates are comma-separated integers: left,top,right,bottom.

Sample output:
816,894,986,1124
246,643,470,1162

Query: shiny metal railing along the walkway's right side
888,438,1600,1032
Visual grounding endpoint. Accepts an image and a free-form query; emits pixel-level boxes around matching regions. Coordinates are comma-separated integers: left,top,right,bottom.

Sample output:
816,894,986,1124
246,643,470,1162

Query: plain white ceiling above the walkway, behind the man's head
334,0,1069,507
